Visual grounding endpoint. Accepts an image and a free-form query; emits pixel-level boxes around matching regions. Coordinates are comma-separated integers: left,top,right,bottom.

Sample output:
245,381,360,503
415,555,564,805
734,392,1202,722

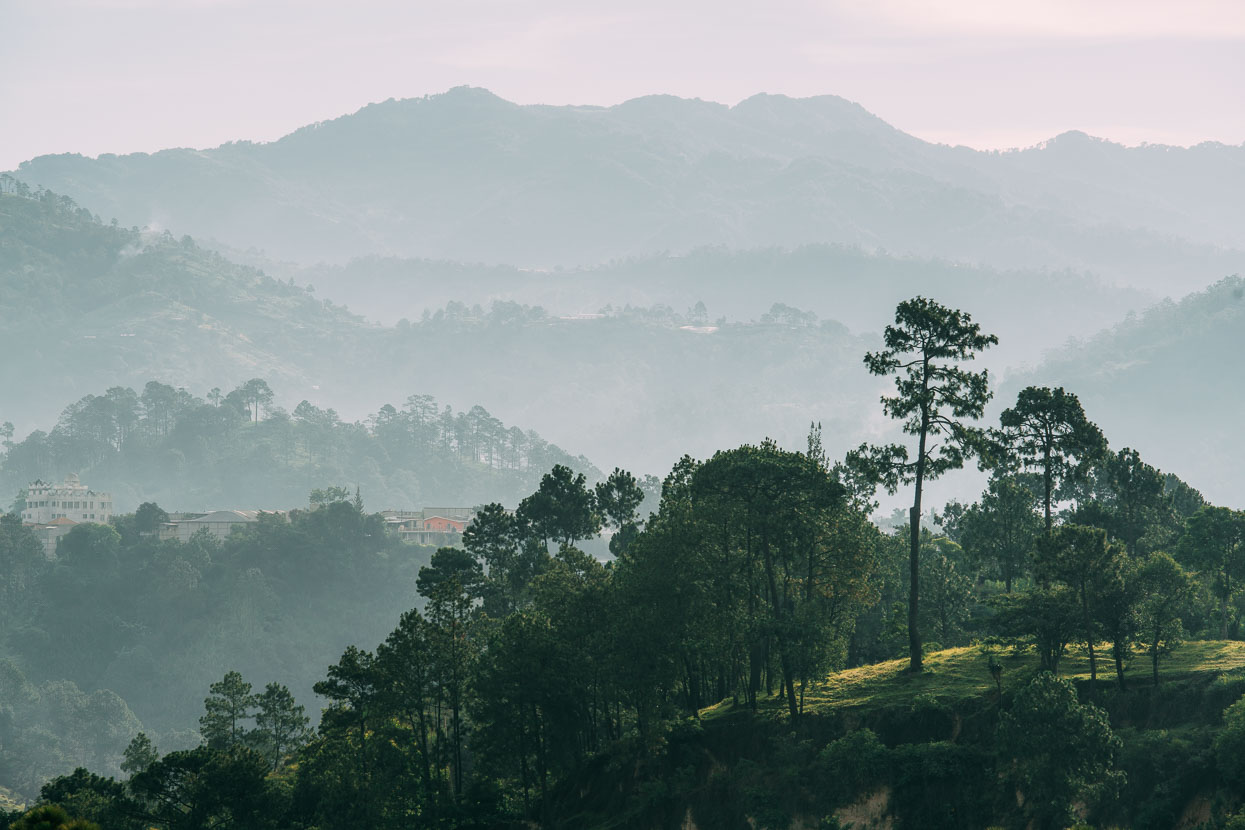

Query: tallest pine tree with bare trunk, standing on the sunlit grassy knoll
848,297,998,672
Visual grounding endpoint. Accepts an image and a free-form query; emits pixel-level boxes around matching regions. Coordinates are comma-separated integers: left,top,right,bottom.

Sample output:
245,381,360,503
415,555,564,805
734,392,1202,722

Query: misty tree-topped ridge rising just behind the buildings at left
0,378,599,509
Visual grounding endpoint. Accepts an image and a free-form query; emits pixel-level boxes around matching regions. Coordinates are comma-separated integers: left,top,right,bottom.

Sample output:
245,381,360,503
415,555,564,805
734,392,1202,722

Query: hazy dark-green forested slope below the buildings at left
0,501,432,798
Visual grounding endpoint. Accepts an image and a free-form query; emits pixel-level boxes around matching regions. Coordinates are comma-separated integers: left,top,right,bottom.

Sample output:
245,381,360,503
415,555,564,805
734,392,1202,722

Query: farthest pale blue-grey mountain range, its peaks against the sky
12,87,1245,291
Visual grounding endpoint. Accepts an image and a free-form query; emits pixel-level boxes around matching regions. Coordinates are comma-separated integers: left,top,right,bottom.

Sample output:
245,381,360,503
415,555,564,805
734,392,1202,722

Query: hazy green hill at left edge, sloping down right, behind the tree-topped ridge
0,180,362,435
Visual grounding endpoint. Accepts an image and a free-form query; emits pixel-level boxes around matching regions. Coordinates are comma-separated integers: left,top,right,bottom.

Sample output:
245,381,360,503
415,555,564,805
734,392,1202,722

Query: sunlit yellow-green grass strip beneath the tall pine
701,640,1245,719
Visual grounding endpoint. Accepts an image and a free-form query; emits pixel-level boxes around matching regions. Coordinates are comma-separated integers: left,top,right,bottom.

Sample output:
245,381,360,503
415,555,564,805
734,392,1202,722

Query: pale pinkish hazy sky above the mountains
0,0,1245,169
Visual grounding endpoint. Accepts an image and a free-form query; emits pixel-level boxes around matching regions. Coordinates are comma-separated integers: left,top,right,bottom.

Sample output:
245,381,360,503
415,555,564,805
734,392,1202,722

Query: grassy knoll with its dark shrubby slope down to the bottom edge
552,640,1245,830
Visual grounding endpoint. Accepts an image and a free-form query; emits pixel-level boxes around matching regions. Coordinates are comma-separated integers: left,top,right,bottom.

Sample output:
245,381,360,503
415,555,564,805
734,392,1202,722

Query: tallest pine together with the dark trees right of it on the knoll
843,297,1220,686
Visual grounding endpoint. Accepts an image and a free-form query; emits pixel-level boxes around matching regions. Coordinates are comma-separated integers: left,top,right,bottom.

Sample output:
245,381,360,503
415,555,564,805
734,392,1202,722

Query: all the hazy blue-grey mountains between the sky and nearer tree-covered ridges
0,88,1245,503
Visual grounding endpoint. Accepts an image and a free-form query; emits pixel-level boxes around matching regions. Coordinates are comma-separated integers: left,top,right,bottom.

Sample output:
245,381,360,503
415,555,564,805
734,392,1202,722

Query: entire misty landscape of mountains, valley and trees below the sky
0,87,1245,830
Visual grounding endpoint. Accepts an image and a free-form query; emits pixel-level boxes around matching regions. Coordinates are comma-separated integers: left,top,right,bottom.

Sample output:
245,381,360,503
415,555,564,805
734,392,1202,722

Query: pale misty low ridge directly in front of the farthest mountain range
291,245,1149,371
